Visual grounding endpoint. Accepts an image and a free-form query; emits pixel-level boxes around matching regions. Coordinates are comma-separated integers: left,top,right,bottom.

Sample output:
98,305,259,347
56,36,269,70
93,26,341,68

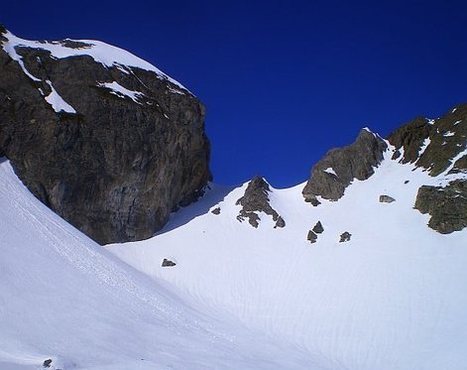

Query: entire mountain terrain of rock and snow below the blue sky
0,28,467,370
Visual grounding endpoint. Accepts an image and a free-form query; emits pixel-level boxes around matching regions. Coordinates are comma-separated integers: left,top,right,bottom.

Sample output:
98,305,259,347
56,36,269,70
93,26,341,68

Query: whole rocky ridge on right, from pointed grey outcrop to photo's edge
303,104,467,233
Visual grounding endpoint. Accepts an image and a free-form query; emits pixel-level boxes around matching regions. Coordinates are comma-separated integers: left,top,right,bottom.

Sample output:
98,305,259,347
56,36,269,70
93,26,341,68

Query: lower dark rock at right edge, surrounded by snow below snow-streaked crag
415,180,467,234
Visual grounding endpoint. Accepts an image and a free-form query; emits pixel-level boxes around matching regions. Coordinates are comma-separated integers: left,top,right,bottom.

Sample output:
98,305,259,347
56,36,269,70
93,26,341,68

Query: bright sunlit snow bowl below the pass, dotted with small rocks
108,143,467,370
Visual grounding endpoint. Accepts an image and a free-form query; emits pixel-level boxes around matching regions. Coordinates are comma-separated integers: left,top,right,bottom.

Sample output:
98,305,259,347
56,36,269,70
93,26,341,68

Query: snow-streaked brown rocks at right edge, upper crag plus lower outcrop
389,104,467,234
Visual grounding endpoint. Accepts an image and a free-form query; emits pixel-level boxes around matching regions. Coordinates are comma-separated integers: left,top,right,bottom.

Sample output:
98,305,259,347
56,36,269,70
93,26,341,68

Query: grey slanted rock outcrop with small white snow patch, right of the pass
302,129,387,206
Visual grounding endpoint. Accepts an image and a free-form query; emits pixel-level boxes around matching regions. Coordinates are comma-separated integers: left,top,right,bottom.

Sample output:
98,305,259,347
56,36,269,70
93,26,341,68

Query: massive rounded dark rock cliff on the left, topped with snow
0,30,211,244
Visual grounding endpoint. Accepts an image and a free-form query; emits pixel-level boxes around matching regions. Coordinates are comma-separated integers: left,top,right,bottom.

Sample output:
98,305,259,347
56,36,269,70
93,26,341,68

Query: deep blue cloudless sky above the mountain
0,0,467,187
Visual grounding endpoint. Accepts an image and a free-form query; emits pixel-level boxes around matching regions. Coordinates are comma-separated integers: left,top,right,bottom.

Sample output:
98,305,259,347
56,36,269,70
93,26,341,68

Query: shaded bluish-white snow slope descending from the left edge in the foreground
0,159,321,370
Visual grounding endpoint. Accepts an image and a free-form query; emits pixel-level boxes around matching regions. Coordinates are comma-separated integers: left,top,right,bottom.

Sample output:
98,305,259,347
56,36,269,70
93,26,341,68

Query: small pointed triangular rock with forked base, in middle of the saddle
236,176,285,228
